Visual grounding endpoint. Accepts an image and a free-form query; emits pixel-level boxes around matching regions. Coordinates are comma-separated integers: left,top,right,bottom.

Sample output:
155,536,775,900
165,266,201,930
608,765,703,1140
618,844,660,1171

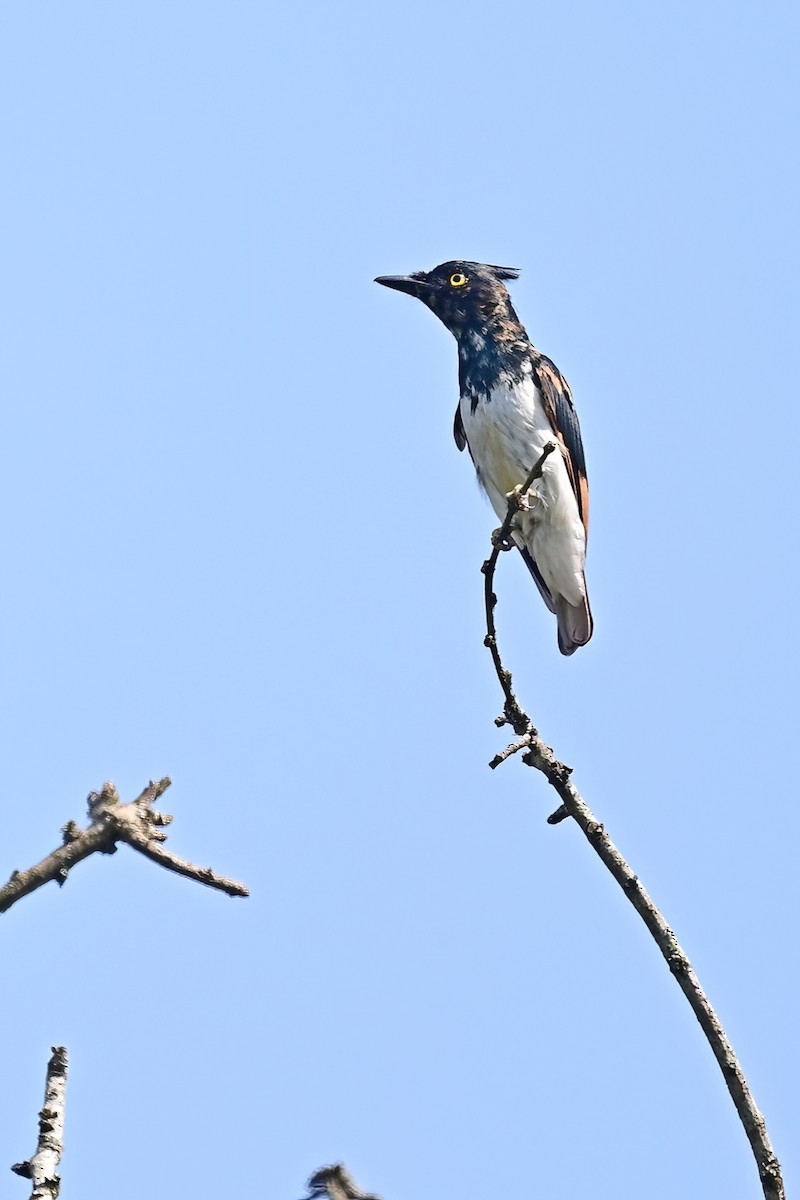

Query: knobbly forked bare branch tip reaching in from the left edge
0,778,249,912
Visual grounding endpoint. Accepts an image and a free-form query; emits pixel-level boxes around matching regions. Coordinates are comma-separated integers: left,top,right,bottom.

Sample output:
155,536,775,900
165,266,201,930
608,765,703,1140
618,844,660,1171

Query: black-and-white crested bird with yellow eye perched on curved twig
375,259,594,654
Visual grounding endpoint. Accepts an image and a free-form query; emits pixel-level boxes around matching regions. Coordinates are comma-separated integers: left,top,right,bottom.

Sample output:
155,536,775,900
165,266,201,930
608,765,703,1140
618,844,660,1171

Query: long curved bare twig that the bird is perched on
481,465,786,1200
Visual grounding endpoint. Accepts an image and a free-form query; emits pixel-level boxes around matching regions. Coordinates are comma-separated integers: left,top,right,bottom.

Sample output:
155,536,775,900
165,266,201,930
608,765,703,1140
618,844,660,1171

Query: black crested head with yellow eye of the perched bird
375,259,519,337
